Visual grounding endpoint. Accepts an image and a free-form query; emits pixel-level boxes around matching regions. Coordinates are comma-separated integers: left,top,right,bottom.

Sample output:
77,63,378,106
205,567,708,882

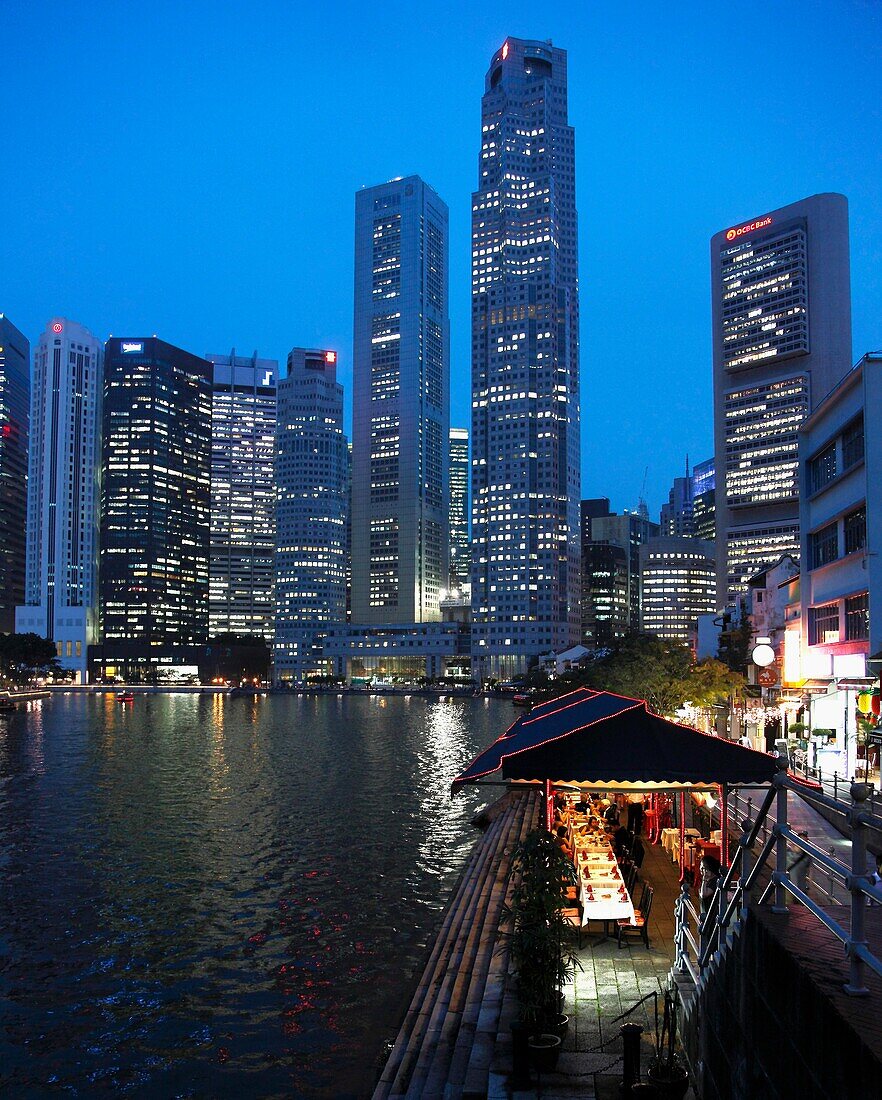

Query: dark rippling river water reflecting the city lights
0,694,515,1098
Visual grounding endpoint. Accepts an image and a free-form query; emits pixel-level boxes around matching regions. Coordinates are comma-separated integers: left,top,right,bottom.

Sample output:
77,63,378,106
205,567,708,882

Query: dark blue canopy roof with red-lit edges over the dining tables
453,688,779,793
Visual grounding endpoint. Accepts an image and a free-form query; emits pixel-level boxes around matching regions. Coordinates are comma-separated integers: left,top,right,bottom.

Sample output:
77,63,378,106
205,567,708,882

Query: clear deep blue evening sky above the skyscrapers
0,0,882,515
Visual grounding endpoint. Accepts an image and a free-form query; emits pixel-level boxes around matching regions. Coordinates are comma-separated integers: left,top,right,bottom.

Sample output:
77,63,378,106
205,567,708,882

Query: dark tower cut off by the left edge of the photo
0,314,31,634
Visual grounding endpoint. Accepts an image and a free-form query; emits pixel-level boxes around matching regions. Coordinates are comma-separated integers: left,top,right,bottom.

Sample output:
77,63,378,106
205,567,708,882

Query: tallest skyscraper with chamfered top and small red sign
472,39,581,677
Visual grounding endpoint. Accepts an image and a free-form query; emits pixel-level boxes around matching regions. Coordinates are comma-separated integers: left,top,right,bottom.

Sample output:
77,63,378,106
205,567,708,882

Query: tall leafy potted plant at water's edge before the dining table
504,828,578,1073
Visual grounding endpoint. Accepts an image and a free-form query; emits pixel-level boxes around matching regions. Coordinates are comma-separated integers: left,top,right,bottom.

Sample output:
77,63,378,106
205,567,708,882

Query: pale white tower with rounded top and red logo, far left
15,317,103,683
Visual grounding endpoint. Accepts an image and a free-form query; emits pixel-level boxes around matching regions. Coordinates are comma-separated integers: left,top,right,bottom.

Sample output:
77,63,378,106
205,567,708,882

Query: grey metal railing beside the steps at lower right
674,759,882,996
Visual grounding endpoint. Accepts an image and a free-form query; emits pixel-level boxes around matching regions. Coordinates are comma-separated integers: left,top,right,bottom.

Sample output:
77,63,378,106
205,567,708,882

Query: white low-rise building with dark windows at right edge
789,353,882,776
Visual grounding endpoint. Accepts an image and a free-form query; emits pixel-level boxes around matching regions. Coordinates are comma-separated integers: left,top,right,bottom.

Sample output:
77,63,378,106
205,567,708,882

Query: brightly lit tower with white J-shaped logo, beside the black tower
206,349,278,642
